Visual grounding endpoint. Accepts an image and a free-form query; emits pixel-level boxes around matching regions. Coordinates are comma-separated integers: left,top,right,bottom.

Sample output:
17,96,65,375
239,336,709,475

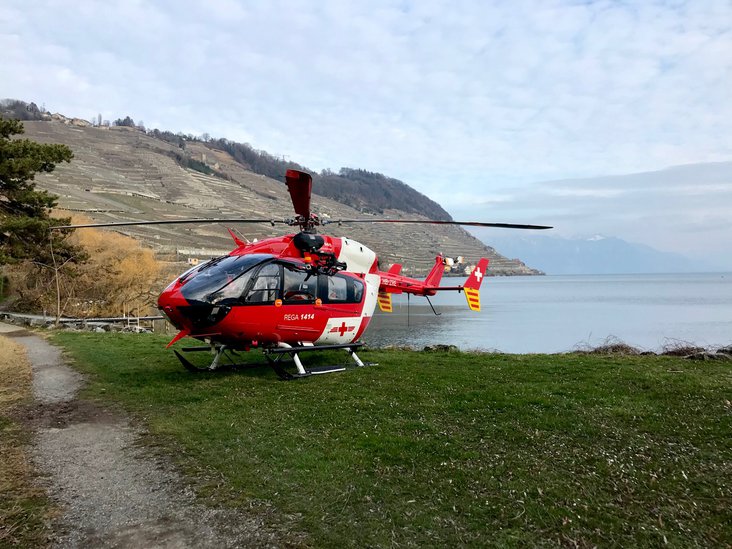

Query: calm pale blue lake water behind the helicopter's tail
363,273,732,353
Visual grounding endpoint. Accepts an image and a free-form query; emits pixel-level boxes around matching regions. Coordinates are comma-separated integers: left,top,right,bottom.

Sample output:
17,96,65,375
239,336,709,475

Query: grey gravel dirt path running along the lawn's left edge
14,335,282,548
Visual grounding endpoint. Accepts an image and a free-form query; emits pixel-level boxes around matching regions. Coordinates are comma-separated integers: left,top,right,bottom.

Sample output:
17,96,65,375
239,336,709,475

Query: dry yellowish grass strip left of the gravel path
0,336,50,547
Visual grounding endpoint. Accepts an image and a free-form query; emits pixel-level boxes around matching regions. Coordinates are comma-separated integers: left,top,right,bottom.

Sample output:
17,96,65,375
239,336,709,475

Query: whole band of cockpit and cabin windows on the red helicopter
179,254,364,307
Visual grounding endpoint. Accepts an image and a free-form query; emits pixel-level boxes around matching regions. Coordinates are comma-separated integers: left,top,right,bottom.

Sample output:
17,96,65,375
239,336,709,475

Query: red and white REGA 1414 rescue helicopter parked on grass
55,170,552,380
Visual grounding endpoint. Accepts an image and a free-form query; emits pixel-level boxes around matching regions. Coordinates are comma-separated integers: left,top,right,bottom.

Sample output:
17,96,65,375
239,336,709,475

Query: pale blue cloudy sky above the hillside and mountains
0,0,732,269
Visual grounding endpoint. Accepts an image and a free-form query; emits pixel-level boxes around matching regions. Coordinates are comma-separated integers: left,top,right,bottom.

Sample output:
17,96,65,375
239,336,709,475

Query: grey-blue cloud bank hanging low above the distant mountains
461,162,732,260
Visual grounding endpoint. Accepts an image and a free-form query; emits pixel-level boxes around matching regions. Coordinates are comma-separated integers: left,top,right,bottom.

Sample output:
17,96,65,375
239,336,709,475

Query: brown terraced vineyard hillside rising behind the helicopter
15,115,537,275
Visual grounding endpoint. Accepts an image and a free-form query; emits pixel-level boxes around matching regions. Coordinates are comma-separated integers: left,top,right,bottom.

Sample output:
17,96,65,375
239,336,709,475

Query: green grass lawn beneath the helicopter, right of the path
54,333,732,547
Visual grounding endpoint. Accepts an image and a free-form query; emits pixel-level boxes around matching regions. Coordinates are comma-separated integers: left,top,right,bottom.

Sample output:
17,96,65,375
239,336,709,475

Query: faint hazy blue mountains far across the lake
486,234,716,275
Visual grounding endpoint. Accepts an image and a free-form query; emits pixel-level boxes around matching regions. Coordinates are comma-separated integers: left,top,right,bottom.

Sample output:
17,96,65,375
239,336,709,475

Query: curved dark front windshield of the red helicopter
181,254,272,301
